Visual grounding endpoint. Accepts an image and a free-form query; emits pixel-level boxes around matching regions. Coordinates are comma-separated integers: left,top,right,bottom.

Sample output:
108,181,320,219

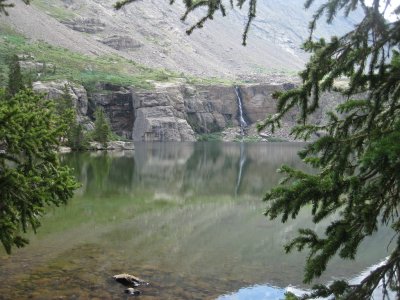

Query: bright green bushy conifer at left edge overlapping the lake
0,90,77,253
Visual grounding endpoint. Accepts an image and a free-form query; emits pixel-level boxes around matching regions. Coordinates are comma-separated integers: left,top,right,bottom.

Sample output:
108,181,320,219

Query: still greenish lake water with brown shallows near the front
0,143,392,300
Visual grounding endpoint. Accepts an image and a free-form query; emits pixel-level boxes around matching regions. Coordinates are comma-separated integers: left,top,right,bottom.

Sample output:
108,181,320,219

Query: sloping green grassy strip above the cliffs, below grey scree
0,29,191,90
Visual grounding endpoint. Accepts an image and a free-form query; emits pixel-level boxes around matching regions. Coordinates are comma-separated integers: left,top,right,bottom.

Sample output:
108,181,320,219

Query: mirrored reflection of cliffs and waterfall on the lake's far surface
63,143,302,199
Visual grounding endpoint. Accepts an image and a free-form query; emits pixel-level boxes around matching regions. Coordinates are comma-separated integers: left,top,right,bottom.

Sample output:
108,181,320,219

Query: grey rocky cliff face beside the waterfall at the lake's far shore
34,81,338,141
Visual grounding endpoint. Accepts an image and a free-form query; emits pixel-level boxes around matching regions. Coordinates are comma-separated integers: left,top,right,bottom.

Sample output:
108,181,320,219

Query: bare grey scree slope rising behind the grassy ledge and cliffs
0,0,359,79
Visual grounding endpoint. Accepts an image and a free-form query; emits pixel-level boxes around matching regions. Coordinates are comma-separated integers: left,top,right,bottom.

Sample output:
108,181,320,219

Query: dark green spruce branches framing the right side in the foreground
116,0,400,299
